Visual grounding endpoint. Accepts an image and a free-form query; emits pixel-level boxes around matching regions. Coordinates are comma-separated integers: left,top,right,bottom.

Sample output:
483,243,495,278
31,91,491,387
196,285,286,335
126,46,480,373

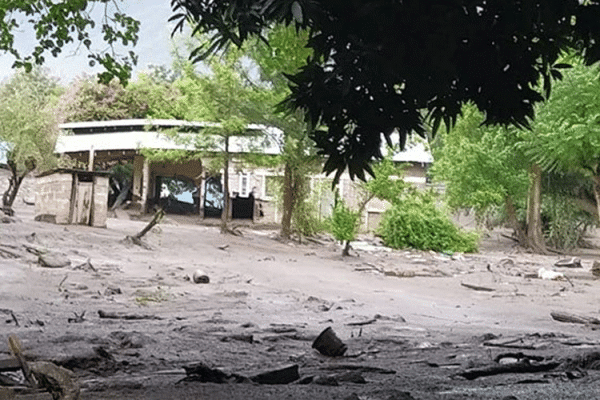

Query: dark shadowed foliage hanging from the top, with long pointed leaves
171,0,600,178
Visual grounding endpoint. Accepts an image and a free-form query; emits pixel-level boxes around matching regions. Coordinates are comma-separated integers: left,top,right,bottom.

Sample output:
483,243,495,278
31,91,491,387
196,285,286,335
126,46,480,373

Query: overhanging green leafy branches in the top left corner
0,0,140,83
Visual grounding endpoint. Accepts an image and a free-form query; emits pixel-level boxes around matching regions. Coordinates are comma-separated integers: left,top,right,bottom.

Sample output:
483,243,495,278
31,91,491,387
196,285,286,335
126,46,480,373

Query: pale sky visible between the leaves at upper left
0,0,183,84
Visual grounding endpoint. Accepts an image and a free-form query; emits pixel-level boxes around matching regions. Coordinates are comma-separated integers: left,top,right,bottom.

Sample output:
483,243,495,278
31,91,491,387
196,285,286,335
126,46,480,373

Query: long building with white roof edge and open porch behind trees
56,119,432,229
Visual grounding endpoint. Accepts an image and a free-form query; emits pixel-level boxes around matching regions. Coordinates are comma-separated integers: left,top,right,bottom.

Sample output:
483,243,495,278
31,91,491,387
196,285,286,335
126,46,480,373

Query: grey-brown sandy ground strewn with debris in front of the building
0,173,600,400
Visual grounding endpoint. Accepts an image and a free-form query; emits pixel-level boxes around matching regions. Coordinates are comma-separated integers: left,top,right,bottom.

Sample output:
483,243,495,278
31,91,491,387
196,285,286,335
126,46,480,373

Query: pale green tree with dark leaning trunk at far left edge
0,69,59,215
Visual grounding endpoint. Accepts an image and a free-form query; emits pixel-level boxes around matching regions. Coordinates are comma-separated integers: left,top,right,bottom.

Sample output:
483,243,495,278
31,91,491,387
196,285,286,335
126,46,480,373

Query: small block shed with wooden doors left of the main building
35,169,110,227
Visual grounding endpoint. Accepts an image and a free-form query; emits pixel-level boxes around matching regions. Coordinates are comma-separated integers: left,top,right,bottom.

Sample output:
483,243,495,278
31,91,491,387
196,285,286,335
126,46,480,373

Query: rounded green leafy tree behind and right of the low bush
431,104,529,246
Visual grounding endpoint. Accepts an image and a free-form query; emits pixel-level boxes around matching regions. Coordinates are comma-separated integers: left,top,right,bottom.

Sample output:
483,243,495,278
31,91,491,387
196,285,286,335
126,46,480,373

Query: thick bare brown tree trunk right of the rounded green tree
527,164,547,253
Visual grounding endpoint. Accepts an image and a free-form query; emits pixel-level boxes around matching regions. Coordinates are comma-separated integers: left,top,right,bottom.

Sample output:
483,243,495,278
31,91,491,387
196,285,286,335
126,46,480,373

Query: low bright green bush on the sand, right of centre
378,193,478,253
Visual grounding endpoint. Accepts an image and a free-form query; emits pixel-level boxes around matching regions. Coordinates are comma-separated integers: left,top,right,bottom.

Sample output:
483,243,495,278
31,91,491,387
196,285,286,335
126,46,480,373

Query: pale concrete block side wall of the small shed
35,173,73,224
